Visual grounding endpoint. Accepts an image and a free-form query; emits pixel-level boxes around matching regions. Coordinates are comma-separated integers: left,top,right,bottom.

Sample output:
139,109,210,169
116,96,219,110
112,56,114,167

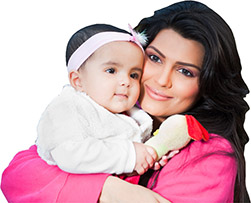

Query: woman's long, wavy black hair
135,1,250,202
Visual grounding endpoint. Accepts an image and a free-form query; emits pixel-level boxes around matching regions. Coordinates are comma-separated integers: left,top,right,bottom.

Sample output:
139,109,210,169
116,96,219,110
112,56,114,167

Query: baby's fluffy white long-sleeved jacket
36,85,152,174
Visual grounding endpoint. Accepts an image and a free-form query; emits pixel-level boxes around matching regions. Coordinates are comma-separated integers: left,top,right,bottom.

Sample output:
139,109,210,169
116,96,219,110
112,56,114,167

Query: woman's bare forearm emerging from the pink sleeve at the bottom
99,176,170,203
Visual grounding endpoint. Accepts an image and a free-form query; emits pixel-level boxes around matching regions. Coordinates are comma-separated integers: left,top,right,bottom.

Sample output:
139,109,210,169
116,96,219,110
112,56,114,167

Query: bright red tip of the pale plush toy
185,115,209,141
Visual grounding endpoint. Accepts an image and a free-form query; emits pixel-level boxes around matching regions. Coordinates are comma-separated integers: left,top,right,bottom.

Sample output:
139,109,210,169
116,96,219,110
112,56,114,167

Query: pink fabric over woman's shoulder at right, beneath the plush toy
154,134,237,202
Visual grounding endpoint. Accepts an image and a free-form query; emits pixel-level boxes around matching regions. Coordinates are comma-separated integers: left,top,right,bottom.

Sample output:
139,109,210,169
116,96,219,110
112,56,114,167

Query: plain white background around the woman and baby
0,0,251,202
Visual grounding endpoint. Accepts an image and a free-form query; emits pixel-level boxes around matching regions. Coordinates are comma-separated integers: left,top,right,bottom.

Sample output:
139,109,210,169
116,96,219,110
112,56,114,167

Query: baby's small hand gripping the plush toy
133,142,157,175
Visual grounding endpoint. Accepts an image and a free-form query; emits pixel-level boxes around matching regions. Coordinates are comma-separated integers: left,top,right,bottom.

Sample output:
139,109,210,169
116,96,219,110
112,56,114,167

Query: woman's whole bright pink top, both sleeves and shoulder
1,135,237,202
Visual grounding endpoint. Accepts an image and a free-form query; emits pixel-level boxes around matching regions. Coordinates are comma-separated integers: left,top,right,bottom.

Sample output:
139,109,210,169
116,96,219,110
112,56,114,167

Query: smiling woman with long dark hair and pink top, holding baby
2,1,250,202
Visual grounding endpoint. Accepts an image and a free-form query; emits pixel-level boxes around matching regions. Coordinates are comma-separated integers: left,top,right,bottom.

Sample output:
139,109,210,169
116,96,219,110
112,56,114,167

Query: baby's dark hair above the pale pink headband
65,24,130,66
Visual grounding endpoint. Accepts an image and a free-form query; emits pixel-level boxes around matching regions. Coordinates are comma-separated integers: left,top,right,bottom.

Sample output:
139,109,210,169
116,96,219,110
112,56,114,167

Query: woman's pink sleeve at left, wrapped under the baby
1,146,109,202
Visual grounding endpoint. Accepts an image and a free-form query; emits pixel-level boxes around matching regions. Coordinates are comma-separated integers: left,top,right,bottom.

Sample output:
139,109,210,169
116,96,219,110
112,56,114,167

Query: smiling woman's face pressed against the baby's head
139,29,204,121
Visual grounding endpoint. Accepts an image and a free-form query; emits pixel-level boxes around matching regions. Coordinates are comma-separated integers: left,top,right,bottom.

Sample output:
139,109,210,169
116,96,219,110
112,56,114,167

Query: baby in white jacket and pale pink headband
36,24,157,175
